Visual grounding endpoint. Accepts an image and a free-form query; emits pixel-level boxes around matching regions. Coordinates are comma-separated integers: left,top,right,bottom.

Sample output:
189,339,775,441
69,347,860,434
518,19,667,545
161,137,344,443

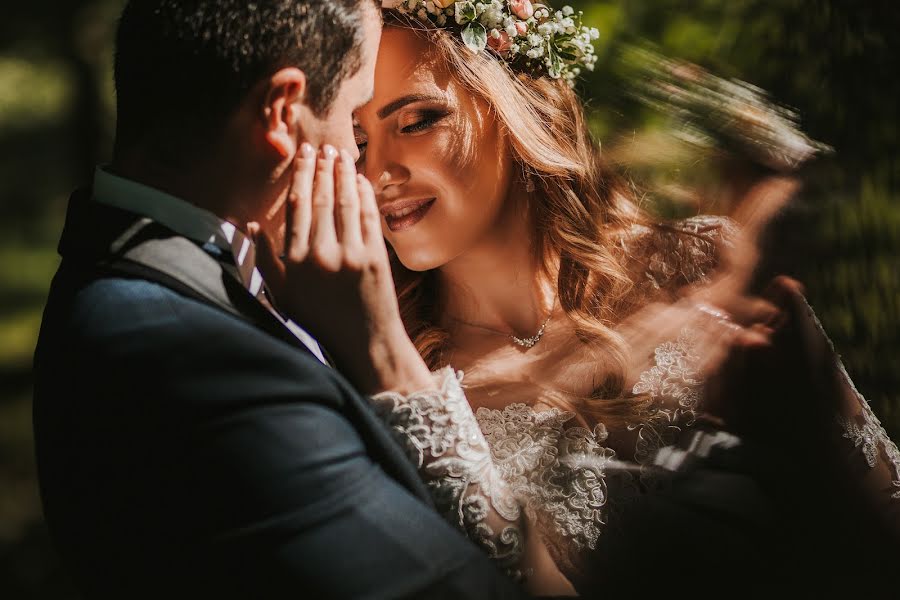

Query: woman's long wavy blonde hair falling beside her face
385,11,648,424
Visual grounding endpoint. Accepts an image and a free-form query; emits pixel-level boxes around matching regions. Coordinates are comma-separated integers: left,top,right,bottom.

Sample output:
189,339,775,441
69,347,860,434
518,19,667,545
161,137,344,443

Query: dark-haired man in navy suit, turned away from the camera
34,0,519,599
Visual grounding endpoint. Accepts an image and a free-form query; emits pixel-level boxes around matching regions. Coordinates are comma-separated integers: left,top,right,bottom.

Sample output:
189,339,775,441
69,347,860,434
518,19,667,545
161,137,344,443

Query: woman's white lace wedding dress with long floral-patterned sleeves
374,218,900,592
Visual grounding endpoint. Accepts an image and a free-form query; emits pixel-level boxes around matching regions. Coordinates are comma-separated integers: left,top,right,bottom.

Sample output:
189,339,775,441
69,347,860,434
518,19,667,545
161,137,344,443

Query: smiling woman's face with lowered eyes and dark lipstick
357,27,511,271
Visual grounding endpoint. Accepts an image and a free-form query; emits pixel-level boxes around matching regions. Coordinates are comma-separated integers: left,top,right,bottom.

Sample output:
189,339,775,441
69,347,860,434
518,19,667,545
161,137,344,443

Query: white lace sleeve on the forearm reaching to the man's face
372,367,524,580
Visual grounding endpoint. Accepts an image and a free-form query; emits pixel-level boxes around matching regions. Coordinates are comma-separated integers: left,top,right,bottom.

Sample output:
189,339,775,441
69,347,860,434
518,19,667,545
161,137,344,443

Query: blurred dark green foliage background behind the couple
0,0,900,599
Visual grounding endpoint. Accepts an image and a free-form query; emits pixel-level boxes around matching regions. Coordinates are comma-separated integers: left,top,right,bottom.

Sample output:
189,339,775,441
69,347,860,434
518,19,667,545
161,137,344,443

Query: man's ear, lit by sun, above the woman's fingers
263,67,306,158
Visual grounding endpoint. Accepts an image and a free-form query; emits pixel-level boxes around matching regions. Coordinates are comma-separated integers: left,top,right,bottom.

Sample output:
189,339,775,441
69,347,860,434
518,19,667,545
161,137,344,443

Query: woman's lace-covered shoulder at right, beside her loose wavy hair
619,215,738,292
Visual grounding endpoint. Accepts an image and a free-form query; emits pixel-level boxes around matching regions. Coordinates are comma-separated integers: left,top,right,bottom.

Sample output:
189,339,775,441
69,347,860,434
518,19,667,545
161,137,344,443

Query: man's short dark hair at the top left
115,0,380,158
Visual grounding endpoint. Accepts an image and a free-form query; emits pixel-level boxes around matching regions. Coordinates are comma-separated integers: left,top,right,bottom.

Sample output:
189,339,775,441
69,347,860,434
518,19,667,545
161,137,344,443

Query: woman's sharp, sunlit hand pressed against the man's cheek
248,144,433,393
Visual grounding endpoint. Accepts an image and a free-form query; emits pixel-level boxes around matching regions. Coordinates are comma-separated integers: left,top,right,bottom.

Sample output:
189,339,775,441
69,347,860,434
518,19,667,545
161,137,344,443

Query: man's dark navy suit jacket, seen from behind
34,193,519,599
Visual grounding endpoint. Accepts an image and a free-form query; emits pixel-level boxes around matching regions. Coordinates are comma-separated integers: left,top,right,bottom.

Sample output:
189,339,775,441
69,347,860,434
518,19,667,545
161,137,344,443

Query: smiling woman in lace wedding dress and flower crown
256,0,900,595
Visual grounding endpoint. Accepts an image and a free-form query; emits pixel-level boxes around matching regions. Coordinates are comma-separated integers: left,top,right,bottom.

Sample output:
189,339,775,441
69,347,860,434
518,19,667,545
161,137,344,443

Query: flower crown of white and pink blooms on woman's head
382,0,600,85
